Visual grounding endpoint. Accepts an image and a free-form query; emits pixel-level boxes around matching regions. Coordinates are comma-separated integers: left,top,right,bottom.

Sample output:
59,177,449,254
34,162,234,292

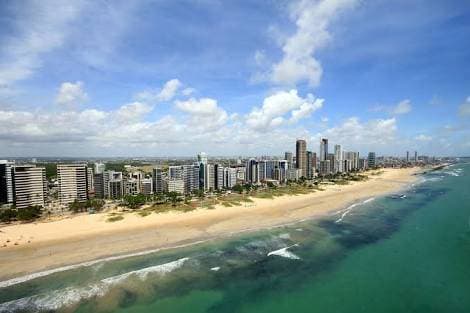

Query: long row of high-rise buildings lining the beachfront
0,138,436,209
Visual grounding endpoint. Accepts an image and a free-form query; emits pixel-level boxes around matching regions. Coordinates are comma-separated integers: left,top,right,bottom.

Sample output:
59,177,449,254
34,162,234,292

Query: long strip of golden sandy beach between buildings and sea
0,169,418,281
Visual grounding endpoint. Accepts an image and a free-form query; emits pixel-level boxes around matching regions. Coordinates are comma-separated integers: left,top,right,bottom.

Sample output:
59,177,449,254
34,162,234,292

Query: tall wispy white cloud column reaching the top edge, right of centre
271,0,357,86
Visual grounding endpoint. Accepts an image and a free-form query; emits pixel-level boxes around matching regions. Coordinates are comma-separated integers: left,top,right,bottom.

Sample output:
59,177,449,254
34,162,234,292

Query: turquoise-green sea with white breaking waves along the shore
0,164,470,313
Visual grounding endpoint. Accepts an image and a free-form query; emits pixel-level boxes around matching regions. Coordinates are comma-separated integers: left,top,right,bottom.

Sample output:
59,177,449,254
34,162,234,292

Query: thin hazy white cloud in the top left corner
0,1,83,86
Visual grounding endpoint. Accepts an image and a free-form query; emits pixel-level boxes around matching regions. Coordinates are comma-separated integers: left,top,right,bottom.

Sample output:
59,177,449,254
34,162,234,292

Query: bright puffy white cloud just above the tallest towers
246,89,324,131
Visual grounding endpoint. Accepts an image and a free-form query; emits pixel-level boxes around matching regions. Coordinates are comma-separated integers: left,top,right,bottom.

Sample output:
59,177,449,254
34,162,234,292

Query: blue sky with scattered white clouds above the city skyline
0,0,470,157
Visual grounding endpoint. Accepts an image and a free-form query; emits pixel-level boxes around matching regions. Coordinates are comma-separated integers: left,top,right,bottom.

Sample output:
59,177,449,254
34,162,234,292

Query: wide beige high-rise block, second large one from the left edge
57,164,89,205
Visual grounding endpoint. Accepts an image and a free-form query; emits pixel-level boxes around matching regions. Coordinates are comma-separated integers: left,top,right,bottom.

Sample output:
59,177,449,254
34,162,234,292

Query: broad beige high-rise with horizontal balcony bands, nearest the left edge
12,165,47,210
